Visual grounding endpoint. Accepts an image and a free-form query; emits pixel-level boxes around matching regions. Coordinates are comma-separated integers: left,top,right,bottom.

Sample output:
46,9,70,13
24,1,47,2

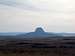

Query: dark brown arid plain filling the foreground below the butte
0,38,75,56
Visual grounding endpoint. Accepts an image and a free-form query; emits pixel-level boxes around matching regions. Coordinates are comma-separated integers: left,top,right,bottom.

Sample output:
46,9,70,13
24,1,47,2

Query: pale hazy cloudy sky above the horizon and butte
0,0,75,32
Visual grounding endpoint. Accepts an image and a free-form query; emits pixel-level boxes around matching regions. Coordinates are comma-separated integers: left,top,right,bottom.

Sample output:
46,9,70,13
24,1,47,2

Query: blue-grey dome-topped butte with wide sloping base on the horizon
19,27,59,38
